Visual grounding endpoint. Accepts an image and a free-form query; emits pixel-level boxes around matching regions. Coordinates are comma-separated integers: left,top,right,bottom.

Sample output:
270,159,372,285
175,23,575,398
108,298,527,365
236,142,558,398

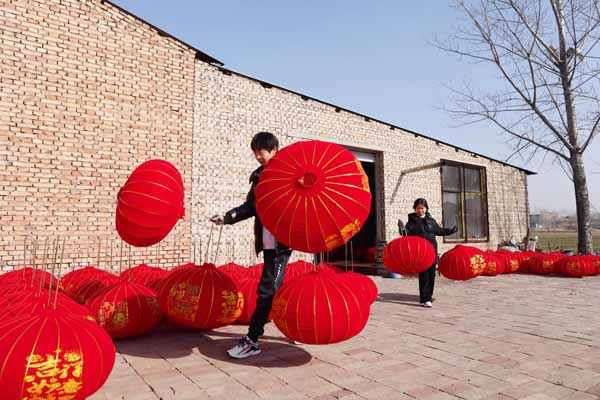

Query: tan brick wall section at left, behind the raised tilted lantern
0,0,195,269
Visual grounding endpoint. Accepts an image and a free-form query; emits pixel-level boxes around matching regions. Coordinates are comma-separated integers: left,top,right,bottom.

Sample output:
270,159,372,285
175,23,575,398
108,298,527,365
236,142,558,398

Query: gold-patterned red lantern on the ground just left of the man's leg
159,264,244,329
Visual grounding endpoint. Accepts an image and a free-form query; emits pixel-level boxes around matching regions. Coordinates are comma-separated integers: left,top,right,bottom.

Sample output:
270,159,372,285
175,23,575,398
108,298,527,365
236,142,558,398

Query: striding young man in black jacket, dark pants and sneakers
211,132,292,358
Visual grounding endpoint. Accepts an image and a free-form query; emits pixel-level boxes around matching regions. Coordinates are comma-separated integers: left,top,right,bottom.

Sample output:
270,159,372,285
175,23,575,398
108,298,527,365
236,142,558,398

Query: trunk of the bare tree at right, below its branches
570,151,594,254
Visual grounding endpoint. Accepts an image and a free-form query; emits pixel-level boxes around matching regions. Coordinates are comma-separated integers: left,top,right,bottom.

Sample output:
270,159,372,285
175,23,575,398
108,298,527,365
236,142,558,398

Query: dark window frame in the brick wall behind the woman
440,159,490,243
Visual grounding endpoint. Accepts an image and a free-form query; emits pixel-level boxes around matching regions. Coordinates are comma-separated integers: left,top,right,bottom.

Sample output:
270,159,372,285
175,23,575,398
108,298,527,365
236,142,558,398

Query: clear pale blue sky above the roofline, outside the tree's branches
113,0,600,212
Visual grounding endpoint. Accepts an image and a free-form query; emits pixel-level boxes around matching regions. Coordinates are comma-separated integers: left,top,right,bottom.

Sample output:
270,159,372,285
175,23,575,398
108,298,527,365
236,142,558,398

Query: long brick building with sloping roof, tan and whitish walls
0,0,530,276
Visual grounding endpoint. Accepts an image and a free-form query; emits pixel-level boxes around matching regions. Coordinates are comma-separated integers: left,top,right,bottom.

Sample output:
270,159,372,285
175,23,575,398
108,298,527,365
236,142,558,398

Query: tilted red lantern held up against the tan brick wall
116,160,185,247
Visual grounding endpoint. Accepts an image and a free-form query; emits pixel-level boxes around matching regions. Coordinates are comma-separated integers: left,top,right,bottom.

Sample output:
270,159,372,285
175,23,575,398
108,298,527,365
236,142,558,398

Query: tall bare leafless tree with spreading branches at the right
435,0,600,253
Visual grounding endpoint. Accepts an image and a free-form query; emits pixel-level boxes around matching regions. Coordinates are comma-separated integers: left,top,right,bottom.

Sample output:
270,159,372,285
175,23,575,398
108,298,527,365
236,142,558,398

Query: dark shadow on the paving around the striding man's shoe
115,323,312,368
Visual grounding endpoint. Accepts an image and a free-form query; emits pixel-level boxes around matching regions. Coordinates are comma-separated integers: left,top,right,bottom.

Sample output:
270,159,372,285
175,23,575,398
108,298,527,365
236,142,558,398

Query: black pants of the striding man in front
248,250,292,342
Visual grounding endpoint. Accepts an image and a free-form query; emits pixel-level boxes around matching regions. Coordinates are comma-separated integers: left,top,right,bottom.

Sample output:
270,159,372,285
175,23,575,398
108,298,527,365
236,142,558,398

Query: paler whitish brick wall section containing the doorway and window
192,62,527,268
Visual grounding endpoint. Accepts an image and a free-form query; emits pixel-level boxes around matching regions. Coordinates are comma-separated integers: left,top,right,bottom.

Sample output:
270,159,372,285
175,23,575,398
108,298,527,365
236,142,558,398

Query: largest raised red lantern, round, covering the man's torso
256,141,371,253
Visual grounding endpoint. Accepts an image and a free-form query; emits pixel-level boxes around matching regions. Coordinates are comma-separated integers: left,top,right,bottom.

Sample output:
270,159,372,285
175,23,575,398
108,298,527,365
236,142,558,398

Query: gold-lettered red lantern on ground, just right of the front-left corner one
88,281,161,339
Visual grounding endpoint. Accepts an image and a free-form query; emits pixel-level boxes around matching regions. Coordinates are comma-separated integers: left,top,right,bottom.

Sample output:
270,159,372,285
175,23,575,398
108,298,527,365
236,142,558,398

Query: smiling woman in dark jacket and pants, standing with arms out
406,199,458,307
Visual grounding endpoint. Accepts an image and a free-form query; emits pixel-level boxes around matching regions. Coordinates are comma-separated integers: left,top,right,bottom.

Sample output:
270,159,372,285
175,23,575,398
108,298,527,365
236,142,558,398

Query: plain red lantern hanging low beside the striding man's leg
272,272,370,344
